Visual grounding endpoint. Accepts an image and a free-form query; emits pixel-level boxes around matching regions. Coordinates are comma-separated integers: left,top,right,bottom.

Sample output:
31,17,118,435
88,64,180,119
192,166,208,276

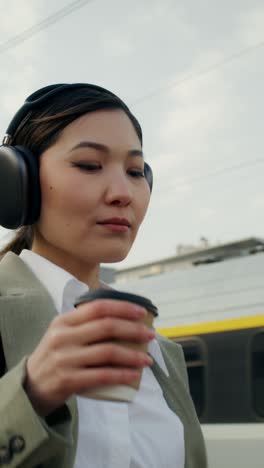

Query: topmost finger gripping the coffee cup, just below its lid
62,299,147,326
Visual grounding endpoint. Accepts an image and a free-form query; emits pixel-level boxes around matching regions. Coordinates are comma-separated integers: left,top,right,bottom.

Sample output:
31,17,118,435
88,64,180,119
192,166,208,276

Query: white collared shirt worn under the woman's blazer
20,250,185,468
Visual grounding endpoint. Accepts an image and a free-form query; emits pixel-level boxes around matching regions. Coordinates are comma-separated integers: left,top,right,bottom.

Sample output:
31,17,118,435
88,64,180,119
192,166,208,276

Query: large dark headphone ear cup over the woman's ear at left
0,146,40,229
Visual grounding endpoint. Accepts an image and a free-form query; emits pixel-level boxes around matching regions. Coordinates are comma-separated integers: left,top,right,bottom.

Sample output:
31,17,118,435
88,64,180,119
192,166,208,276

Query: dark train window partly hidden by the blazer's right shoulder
174,337,206,418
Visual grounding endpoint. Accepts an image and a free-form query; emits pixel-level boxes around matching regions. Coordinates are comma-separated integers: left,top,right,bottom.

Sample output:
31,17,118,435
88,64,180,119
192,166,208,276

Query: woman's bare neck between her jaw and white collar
31,240,101,289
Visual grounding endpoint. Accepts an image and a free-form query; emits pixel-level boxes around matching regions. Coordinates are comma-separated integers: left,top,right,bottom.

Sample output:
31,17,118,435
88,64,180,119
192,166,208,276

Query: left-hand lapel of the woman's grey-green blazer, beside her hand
0,252,77,419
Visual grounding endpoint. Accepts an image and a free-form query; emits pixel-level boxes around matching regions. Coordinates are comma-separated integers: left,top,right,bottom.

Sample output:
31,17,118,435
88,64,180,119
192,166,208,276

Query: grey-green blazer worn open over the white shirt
0,253,207,468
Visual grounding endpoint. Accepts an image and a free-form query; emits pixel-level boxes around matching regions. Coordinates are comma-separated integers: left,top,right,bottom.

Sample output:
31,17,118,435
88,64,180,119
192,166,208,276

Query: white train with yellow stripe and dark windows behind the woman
113,252,264,468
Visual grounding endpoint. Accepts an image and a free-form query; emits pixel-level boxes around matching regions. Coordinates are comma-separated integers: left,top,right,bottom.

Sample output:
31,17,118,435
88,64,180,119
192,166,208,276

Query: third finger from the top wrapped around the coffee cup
54,343,153,369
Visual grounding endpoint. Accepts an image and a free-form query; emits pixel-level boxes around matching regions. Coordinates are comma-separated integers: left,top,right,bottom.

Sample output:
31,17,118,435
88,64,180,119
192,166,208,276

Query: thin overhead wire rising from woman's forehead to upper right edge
131,40,264,106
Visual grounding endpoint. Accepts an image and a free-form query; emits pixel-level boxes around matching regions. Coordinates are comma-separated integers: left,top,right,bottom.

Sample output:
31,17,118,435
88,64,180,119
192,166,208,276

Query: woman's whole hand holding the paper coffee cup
24,299,154,416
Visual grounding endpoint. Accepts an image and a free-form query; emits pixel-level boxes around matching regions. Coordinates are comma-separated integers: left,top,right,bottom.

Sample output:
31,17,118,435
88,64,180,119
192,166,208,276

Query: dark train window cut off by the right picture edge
251,332,264,417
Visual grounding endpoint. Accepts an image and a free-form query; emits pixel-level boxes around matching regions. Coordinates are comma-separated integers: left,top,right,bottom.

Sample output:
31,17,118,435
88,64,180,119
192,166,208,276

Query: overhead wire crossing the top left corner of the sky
0,0,95,54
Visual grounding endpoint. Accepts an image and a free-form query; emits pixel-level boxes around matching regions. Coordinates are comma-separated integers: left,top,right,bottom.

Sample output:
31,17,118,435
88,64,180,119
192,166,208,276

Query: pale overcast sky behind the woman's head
0,0,264,268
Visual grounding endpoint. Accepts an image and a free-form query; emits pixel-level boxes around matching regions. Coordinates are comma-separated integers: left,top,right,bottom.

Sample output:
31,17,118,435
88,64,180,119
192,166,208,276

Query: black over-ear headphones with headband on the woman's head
0,83,153,229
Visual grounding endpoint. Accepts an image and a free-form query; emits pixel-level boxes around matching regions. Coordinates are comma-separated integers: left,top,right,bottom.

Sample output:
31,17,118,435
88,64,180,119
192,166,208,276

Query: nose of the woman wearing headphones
105,171,132,207
